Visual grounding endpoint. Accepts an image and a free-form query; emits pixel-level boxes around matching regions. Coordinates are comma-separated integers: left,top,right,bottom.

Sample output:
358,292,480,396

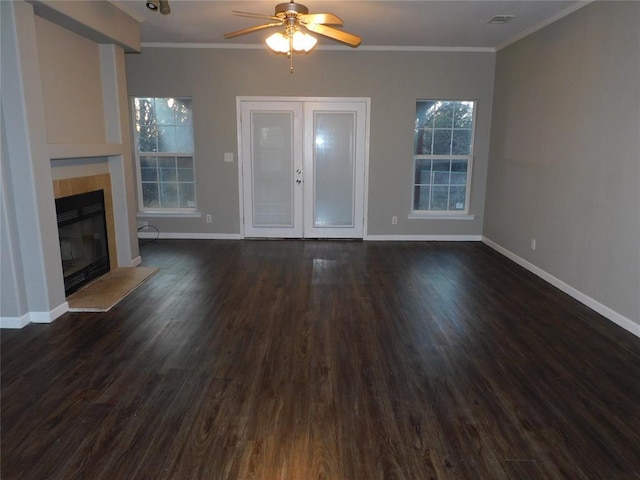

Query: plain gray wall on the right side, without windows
484,2,640,331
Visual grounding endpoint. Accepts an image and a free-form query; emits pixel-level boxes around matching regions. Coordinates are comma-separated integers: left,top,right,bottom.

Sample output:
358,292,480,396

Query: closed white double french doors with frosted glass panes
239,99,368,238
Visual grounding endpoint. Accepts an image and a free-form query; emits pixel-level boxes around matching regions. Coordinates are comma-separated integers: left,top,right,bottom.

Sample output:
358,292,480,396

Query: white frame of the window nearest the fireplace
129,95,200,216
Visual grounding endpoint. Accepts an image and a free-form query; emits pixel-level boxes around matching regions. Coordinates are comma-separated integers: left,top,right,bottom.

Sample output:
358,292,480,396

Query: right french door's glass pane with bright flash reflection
313,112,356,227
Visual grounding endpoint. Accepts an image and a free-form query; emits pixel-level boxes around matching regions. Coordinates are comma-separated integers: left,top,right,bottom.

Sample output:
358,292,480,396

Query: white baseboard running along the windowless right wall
482,237,640,337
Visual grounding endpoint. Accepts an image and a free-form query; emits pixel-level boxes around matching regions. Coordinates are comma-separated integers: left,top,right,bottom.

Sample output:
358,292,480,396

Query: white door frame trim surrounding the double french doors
236,96,371,239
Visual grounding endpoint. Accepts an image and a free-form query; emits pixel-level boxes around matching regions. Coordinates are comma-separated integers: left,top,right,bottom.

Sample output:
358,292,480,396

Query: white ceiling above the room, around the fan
112,0,589,50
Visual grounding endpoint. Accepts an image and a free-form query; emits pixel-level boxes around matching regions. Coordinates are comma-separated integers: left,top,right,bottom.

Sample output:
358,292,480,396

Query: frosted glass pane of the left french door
251,112,294,227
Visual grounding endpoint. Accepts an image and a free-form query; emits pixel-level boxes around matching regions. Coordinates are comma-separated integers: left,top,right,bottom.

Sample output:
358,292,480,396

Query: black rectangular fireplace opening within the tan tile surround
56,190,109,296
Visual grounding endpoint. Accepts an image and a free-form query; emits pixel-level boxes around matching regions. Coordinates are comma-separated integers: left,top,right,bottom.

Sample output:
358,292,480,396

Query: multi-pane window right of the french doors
412,100,475,214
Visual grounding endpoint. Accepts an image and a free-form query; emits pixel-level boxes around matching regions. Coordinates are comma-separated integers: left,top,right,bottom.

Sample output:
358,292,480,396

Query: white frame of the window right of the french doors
408,98,478,220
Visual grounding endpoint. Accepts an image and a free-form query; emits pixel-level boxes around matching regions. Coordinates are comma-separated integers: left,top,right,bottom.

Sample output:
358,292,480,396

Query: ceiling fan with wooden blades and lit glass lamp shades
224,0,362,50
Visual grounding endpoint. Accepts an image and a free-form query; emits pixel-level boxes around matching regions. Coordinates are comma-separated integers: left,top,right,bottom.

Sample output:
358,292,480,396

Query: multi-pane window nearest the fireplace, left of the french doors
132,97,196,212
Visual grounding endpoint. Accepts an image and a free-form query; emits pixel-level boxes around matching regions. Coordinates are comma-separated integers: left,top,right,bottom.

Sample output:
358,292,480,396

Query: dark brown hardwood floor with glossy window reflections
1,240,640,480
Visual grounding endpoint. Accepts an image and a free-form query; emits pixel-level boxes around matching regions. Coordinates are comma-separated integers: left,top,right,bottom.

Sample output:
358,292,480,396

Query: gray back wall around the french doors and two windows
126,47,495,236
